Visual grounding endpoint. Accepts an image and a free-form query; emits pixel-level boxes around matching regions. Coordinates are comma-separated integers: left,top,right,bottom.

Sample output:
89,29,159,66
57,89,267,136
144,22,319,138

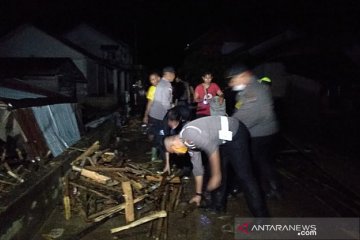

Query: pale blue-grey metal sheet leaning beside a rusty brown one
31,103,80,157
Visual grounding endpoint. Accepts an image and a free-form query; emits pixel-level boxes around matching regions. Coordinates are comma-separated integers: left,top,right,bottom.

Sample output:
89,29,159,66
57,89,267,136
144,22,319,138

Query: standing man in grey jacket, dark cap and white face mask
225,64,280,198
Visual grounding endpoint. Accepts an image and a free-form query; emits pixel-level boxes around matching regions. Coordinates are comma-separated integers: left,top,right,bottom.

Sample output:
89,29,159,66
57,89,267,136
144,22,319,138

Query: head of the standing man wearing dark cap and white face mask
225,64,252,90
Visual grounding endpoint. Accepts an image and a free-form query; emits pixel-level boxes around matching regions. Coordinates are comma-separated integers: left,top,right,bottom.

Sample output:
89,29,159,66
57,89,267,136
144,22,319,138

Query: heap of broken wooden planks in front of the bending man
63,142,183,239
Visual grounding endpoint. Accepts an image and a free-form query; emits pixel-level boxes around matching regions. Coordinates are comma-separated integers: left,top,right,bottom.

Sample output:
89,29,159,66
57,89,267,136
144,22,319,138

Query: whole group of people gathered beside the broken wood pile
143,64,281,217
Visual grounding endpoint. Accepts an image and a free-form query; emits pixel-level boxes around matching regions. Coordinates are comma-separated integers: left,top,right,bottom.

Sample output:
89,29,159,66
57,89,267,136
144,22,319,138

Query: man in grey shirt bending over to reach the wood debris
164,116,268,217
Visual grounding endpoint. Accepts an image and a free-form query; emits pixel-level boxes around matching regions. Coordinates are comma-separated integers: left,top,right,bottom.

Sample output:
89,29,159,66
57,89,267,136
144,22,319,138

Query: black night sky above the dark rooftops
0,0,360,66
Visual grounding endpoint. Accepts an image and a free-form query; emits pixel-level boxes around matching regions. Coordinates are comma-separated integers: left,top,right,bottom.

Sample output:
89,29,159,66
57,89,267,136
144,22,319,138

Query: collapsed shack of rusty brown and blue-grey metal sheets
0,79,81,165
